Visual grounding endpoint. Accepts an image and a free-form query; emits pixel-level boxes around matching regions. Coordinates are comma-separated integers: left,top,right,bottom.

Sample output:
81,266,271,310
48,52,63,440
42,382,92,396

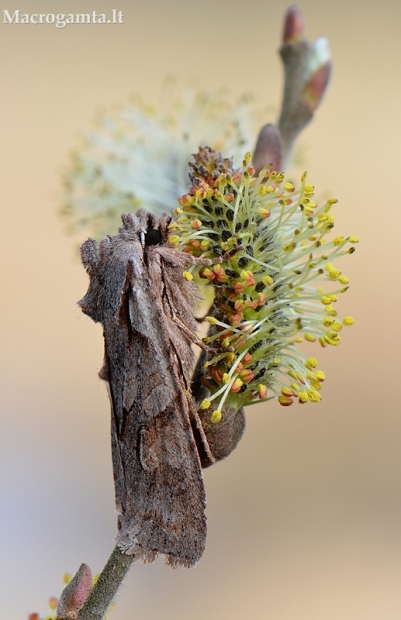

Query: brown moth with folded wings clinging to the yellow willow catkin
79,209,244,568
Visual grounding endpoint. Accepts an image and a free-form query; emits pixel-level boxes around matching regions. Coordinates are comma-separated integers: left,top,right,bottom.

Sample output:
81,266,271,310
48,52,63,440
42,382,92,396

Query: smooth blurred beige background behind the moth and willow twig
0,0,401,620
